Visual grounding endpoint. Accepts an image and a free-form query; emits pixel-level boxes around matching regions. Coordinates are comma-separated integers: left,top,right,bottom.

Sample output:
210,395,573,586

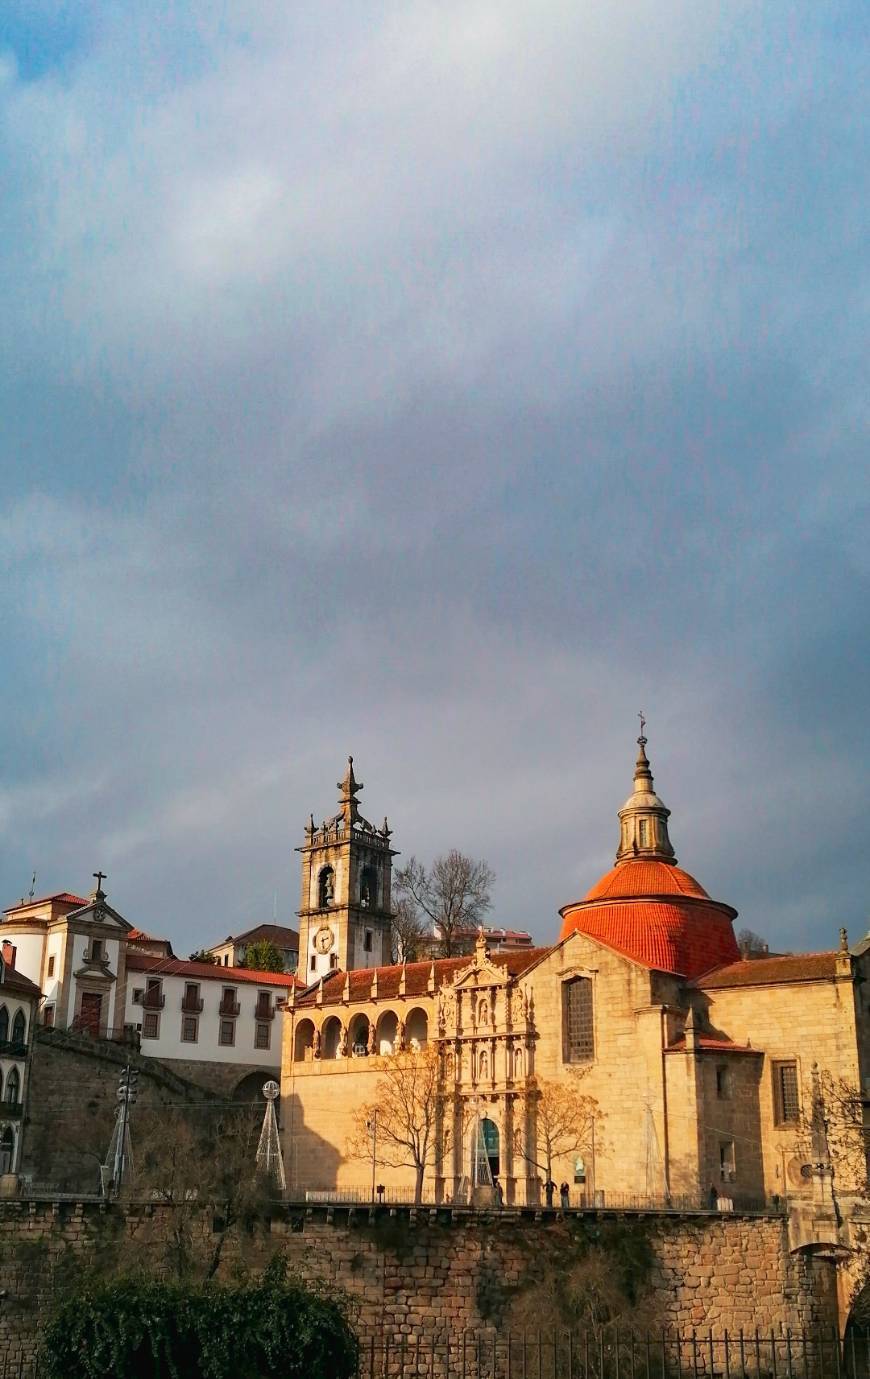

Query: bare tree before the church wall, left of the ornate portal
347,1044,441,1202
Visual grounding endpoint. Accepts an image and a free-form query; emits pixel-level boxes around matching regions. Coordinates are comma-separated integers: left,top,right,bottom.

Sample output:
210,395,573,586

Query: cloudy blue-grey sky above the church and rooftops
0,0,870,953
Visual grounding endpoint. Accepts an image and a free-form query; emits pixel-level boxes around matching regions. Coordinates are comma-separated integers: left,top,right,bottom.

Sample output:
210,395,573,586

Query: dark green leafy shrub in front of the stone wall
40,1260,357,1379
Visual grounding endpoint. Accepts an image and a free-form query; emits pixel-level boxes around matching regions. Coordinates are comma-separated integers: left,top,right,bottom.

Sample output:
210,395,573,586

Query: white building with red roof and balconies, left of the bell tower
0,876,296,1085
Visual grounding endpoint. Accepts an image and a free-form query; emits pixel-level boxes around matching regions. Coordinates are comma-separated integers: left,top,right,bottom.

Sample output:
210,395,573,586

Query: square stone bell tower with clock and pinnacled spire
296,757,396,986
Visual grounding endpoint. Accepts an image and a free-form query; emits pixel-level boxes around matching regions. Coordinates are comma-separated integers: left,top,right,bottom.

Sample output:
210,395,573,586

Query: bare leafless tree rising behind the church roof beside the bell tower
393,848,495,957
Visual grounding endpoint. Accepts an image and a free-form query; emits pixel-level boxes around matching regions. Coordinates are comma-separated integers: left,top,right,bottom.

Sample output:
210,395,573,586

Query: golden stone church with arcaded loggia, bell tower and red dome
281,731,870,1209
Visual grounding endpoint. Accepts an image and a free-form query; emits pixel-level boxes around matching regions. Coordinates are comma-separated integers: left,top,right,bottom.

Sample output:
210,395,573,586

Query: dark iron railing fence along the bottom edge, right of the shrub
357,1327,870,1379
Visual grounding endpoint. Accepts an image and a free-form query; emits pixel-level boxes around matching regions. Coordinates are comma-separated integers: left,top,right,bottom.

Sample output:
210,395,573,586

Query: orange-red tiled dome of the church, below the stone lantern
561,858,739,978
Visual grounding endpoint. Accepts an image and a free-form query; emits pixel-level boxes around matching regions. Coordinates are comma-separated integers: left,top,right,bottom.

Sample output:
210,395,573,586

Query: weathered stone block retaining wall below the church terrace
0,1201,837,1372
